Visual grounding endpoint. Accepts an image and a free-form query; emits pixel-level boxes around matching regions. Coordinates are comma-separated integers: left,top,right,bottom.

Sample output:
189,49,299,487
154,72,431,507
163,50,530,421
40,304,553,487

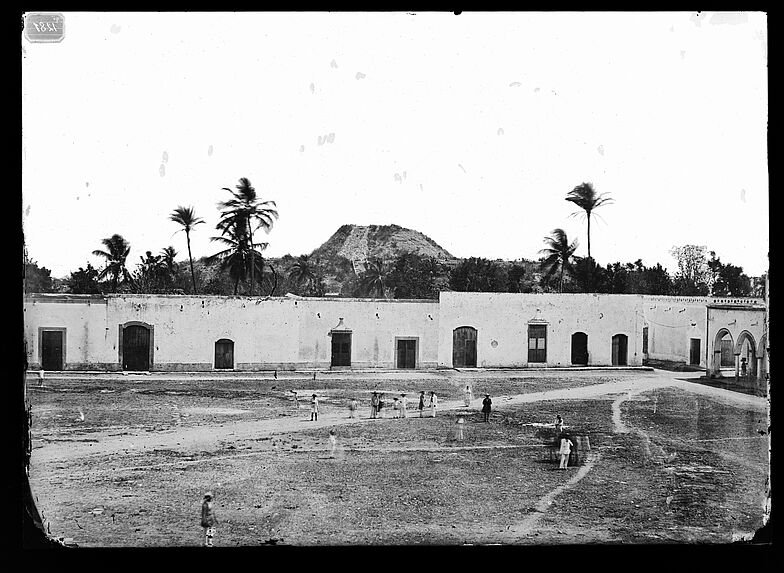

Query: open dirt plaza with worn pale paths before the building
27,370,769,547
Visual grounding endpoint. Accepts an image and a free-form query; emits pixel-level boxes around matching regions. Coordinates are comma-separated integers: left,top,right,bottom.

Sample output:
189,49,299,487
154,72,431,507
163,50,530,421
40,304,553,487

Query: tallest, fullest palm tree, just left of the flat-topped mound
217,177,278,296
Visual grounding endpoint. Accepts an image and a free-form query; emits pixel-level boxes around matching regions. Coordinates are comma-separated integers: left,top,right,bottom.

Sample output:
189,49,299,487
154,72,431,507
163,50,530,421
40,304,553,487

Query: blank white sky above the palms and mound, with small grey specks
21,8,769,278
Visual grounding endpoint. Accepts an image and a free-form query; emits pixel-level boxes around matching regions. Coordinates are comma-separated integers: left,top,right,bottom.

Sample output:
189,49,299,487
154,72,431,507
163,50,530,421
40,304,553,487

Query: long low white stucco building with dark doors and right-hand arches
24,292,768,377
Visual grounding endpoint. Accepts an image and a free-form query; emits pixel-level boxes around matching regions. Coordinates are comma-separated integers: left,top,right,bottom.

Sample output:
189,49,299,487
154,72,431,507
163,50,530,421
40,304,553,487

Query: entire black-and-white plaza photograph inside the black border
17,10,772,544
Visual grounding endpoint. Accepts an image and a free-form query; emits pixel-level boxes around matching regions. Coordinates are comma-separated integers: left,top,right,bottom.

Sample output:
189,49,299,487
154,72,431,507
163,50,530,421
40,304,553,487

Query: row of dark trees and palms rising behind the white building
24,177,764,299
